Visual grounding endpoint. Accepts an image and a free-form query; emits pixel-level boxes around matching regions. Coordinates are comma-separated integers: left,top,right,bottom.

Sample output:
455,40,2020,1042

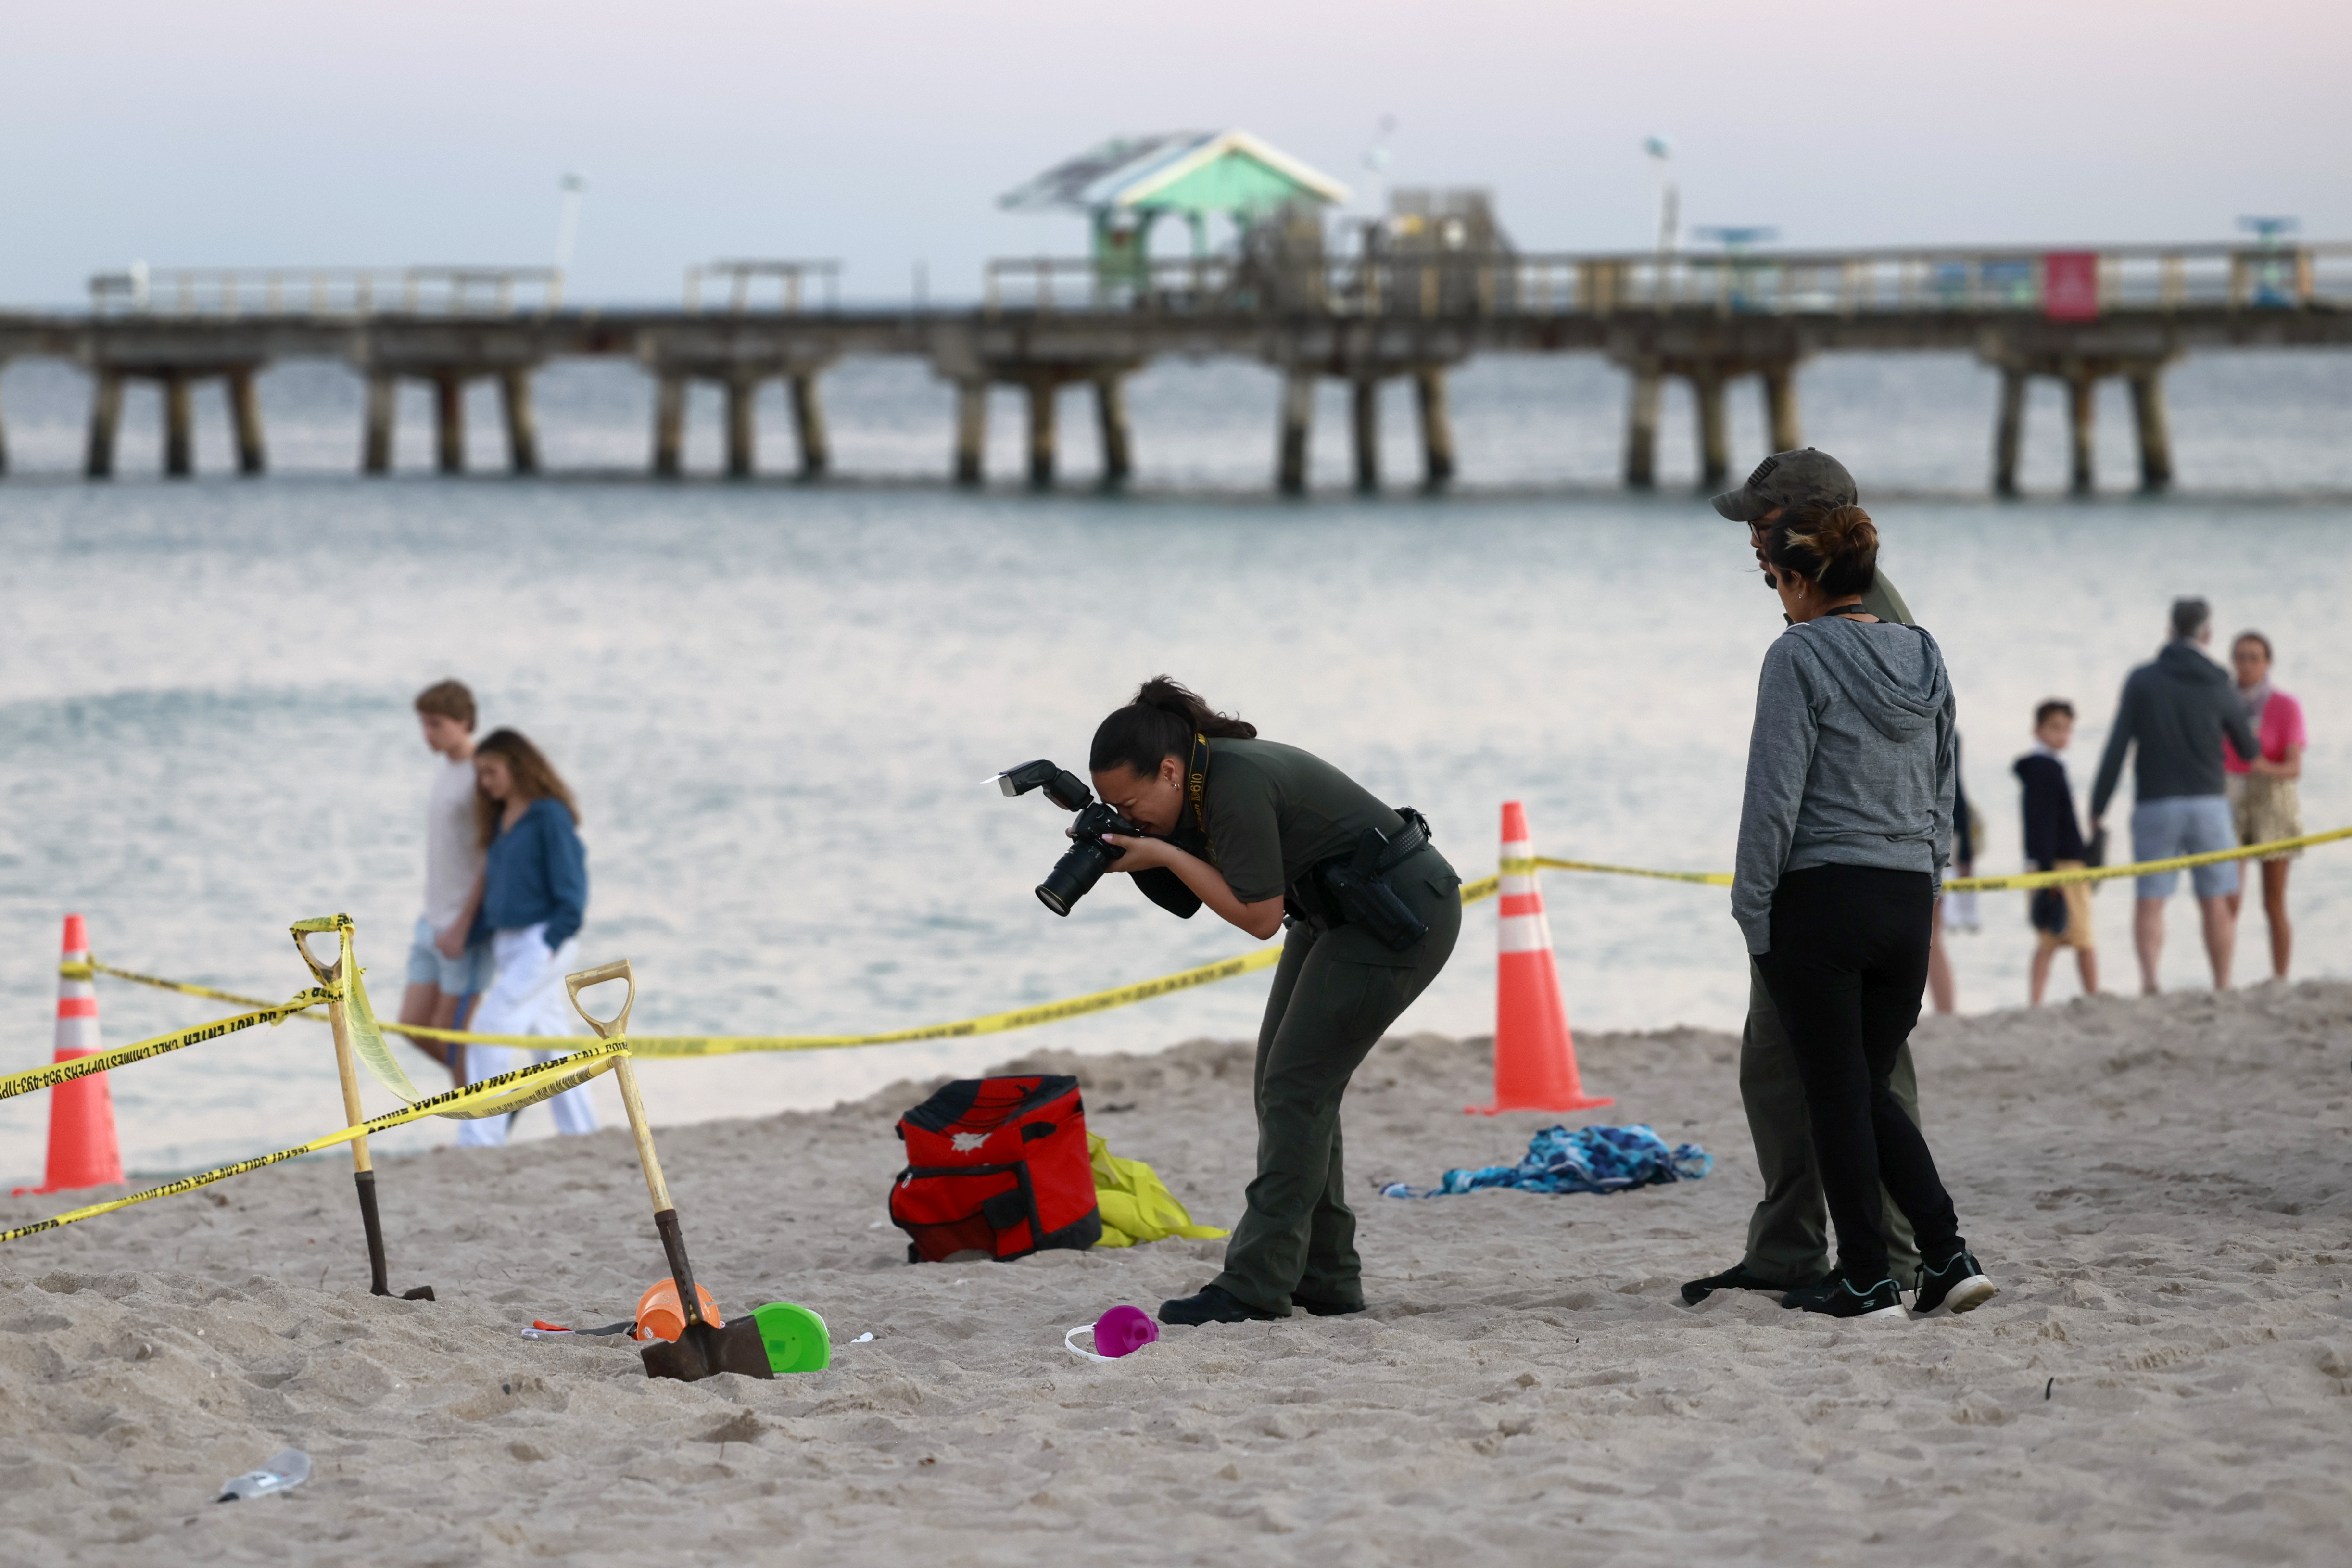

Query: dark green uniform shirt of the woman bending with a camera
1202,741,1404,903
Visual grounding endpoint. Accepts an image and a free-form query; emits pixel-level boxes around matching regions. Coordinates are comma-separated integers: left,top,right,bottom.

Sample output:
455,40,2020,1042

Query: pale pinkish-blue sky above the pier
0,0,2352,305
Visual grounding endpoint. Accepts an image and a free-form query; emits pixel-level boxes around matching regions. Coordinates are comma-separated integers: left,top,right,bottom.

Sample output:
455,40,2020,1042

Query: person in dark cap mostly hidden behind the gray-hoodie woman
1682,447,1919,1307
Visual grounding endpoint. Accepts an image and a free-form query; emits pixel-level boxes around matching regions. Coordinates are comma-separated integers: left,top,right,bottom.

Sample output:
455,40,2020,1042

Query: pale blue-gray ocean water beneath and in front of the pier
0,355,2352,1180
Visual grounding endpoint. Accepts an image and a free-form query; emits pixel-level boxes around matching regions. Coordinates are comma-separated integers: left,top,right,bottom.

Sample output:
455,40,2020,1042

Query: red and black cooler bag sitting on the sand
889,1077,1103,1263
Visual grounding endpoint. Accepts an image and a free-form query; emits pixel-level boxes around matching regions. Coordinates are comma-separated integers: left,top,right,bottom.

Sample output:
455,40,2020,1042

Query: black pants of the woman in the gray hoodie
1757,865,1961,1288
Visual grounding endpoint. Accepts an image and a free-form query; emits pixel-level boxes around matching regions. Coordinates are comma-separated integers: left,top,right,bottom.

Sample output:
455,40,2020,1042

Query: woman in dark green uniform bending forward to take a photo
1087,675,1461,1324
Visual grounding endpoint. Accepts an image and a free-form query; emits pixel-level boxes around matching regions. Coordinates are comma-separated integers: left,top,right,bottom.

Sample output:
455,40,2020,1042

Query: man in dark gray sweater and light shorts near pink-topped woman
2091,599,2263,997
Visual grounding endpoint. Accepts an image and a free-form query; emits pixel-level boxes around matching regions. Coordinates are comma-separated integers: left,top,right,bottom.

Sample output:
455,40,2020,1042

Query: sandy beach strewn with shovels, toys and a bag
0,983,2352,1566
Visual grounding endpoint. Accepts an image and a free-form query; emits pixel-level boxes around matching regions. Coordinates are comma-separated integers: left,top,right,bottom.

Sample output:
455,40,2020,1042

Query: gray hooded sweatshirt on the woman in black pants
1731,616,1957,952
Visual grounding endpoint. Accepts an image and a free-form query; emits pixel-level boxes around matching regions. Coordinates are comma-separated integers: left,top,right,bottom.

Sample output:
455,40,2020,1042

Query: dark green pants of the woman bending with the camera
1214,848,1463,1314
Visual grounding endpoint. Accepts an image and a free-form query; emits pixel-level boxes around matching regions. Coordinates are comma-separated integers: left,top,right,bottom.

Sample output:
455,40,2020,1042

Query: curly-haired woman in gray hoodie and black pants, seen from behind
1731,506,1995,1316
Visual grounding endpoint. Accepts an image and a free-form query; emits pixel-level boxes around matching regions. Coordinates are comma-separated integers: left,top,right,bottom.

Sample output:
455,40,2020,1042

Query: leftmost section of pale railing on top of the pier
89,266,565,320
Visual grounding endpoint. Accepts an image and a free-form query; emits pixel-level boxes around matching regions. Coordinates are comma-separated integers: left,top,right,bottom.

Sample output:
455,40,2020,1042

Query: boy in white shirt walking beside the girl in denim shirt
400,680,489,1088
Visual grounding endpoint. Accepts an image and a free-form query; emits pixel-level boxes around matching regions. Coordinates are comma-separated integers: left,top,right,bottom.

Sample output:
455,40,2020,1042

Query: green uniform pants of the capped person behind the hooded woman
1741,959,1919,1290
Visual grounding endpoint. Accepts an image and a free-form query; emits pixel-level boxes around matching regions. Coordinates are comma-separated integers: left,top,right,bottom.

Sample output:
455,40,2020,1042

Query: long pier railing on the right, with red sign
983,244,2352,320
